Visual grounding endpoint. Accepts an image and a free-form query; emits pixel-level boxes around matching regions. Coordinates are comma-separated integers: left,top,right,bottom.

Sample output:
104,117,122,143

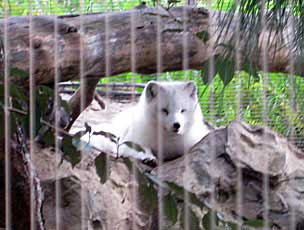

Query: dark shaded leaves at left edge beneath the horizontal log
0,69,90,167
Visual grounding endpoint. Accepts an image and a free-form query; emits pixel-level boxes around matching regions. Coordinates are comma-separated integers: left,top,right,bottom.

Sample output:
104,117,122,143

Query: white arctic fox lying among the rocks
115,81,209,161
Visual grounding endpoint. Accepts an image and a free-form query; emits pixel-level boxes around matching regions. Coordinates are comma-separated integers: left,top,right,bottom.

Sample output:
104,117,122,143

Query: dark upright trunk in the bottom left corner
0,127,45,230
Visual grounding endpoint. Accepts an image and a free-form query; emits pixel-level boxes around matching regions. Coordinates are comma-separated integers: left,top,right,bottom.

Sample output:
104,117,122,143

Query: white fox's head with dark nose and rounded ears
142,81,200,135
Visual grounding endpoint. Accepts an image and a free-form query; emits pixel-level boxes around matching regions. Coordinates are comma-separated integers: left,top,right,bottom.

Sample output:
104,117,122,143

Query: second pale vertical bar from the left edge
29,0,36,230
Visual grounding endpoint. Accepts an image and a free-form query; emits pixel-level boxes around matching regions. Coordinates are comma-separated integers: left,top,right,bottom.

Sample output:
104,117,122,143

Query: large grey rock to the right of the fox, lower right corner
153,121,304,230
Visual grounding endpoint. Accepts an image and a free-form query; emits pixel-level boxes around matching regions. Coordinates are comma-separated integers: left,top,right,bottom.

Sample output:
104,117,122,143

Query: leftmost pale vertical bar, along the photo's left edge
4,2,12,230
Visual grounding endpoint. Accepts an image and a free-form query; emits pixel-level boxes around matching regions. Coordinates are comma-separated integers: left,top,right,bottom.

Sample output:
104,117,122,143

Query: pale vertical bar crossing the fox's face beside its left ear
156,1,164,230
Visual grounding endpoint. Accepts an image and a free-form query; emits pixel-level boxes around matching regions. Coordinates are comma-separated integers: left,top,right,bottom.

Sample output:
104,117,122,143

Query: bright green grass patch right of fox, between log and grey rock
201,73,304,149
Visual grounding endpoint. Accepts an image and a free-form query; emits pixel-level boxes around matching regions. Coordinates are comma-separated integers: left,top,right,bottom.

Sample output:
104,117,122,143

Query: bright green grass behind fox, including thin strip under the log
101,70,304,151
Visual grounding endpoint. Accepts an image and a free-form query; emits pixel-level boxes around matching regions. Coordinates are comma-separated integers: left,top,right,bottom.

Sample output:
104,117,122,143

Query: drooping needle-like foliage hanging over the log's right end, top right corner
213,0,304,63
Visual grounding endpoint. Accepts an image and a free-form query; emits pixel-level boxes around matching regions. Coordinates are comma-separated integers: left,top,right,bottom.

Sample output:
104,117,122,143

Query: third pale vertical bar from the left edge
53,2,61,230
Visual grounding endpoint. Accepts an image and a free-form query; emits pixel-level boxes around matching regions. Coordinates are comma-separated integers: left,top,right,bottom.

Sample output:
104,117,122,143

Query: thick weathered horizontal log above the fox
0,6,304,84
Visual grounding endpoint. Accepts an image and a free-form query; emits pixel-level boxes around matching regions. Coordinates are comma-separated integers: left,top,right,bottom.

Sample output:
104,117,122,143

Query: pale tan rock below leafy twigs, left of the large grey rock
33,147,151,230
